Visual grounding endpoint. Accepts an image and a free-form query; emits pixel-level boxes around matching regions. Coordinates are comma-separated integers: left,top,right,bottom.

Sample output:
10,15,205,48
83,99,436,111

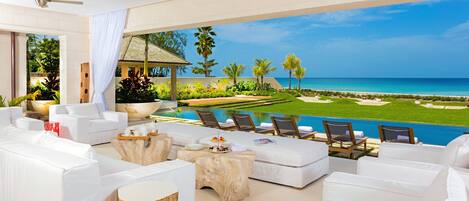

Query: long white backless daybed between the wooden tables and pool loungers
144,123,329,188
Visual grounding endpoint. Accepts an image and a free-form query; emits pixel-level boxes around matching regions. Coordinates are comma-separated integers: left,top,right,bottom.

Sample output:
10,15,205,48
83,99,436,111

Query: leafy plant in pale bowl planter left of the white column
31,73,60,116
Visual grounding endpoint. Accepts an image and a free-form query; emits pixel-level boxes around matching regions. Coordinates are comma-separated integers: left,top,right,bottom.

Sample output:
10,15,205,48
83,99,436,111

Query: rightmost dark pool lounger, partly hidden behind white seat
378,125,418,144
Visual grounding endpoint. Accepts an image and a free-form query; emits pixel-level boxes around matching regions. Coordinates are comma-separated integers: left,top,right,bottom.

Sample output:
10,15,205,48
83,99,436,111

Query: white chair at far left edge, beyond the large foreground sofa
0,107,44,131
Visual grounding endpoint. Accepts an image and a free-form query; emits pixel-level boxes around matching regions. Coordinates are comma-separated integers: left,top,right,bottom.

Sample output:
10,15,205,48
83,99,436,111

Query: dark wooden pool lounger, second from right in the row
323,121,368,158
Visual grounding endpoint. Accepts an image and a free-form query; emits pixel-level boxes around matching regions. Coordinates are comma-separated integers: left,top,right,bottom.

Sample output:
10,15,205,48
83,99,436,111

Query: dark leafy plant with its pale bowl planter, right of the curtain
116,72,161,121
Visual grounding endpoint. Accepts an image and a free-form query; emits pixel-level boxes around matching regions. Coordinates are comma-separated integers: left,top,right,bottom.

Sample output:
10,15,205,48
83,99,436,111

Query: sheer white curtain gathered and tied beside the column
91,10,127,108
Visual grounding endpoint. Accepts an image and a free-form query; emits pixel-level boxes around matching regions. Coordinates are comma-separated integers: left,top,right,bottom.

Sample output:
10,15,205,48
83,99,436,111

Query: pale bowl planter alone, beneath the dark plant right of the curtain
116,101,161,121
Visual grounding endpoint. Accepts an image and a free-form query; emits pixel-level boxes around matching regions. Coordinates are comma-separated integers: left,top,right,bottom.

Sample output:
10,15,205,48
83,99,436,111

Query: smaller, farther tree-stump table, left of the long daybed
111,134,172,165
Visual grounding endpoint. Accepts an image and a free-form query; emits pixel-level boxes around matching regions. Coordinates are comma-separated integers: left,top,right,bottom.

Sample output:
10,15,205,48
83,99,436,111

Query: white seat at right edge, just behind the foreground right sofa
379,134,469,168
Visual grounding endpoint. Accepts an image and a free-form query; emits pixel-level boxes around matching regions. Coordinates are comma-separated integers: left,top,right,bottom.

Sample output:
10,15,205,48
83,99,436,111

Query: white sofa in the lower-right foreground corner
323,157,458,201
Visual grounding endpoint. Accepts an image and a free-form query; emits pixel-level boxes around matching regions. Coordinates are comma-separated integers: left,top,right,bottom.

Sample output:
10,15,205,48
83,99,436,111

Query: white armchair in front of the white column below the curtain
49,103,127,145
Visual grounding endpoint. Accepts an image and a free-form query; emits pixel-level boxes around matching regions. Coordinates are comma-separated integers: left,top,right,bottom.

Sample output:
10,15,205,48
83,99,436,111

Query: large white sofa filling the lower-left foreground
0,126,195,201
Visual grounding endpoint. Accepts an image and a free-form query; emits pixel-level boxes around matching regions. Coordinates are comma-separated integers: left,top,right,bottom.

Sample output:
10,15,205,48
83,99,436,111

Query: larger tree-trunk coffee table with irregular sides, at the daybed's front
177,149,256,201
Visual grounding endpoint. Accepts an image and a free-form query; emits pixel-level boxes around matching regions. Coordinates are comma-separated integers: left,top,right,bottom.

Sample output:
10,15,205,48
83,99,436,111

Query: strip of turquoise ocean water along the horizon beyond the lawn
276,78,469,96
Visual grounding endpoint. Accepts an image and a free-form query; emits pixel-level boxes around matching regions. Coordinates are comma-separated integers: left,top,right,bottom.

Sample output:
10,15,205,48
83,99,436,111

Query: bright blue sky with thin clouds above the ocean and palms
177,0,469,78
